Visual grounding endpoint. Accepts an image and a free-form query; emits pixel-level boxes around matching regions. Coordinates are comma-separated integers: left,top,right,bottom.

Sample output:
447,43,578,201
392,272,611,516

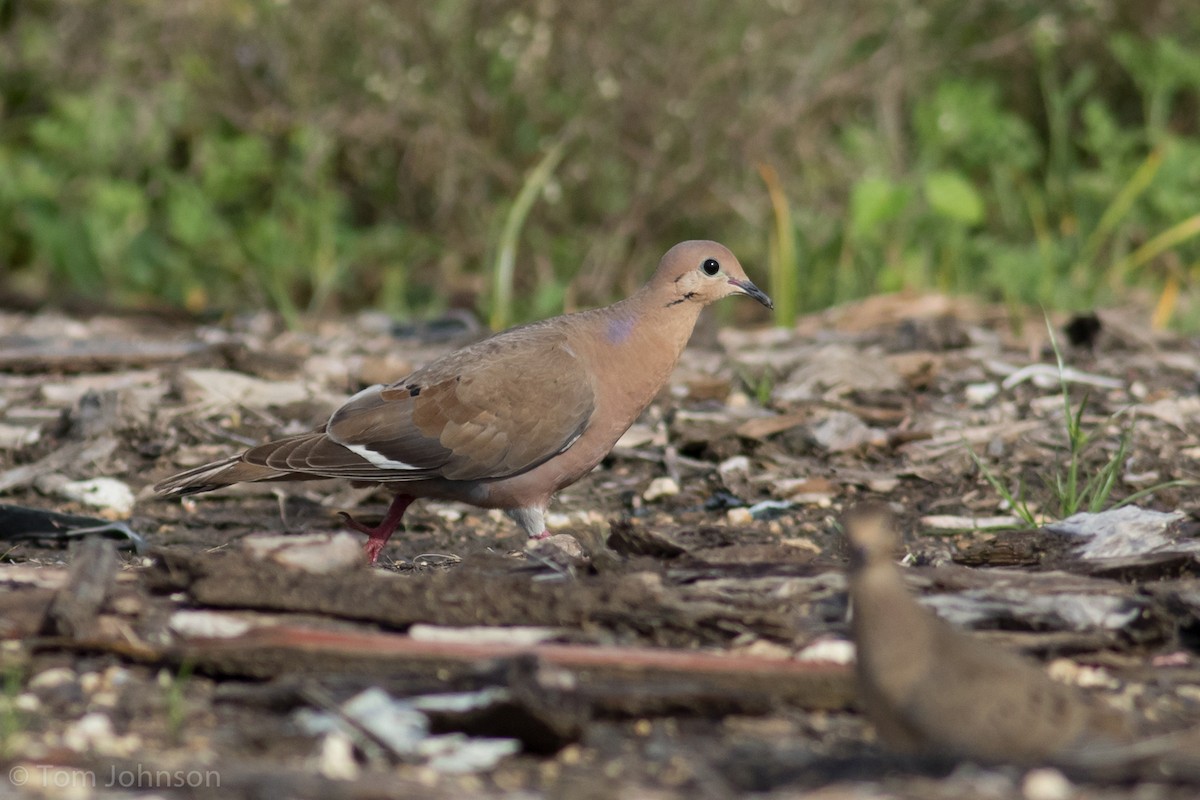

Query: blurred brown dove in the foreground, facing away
845,507,1129,764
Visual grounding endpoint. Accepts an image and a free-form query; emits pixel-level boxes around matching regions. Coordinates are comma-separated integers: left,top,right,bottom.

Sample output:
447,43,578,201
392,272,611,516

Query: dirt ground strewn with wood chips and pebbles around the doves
0,296,1200,800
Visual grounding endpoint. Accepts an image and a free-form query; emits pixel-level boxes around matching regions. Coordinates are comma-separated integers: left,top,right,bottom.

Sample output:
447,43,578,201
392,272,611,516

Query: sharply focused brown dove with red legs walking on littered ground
155,241,770,563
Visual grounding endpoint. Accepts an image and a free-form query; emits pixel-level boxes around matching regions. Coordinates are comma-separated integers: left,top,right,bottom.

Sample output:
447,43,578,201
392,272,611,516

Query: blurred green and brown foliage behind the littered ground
0,0,1200,323
